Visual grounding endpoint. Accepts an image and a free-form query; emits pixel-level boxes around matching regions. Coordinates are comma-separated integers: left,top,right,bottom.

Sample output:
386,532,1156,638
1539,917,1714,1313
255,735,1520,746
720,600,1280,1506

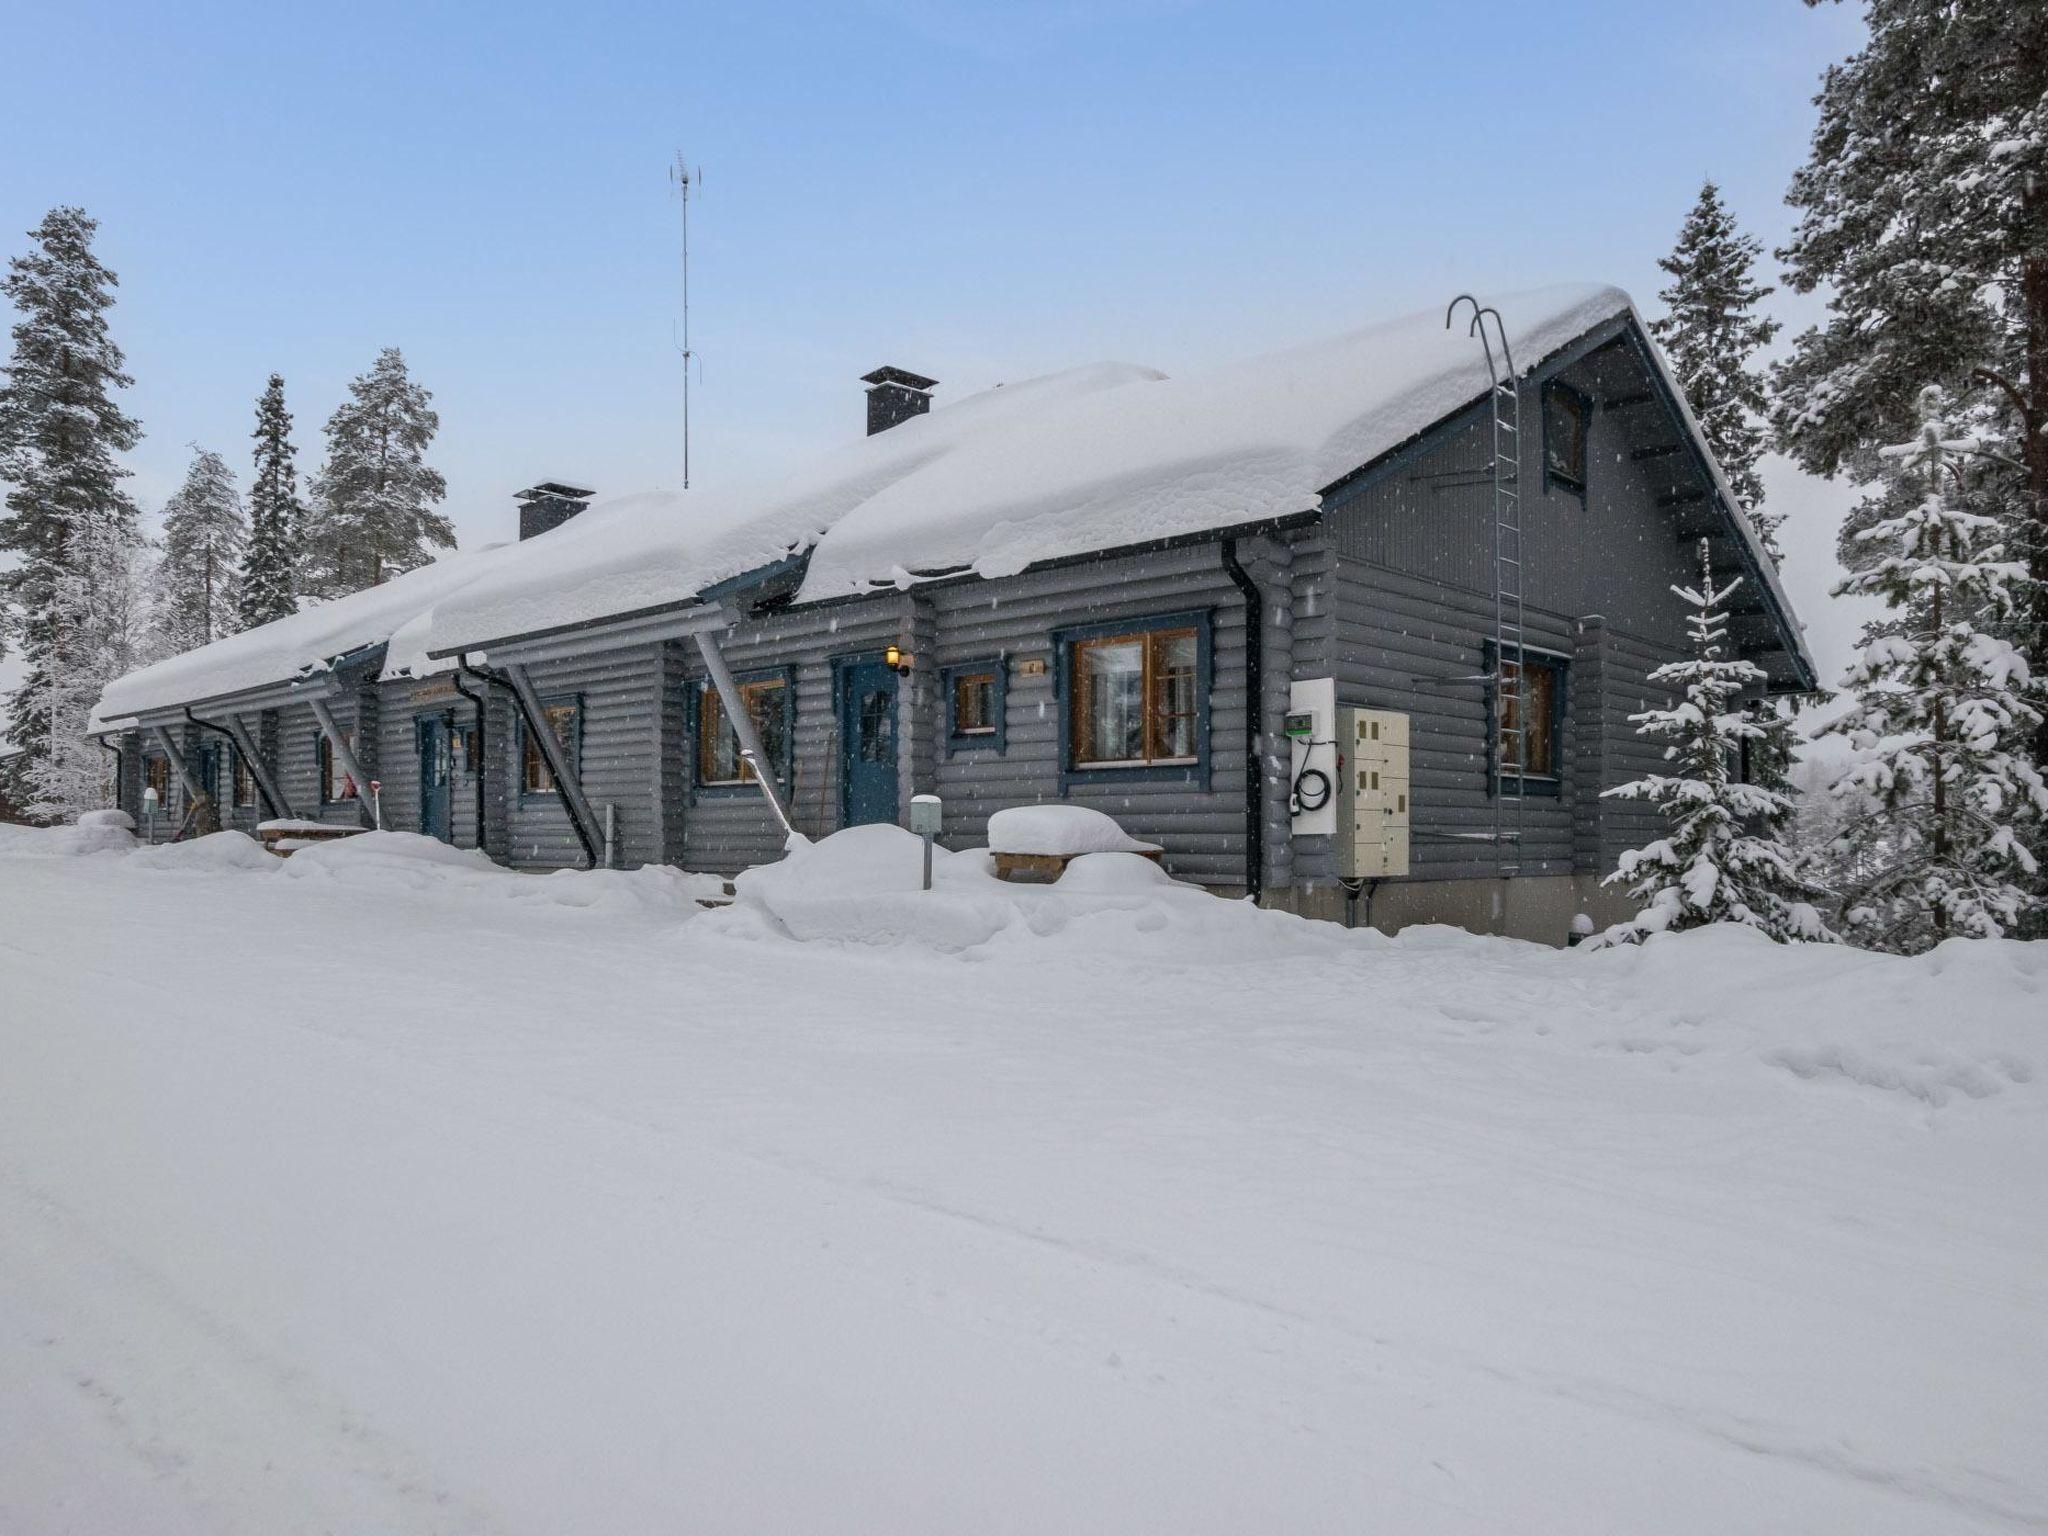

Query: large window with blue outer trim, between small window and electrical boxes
1053,610,1212,788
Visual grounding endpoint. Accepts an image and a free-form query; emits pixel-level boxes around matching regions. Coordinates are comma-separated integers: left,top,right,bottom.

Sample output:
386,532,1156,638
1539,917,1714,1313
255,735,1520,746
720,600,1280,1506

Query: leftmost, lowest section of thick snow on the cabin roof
92,545,504,729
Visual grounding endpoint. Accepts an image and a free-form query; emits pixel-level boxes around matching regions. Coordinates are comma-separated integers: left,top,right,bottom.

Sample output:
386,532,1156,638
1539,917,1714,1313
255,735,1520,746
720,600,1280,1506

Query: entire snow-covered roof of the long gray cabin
83,285,1804,721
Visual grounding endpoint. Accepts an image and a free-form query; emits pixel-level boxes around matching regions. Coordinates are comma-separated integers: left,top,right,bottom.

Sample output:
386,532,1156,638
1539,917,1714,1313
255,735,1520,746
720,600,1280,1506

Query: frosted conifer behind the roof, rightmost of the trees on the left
305,346,455,598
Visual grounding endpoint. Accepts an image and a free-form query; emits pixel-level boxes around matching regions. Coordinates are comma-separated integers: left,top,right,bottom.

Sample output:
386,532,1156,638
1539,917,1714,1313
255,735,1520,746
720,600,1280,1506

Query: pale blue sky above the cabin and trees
0,0,1860,684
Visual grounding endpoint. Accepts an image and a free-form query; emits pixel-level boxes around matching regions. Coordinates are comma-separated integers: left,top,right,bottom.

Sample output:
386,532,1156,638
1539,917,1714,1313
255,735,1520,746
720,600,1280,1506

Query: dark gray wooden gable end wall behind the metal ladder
1296,360,1696,879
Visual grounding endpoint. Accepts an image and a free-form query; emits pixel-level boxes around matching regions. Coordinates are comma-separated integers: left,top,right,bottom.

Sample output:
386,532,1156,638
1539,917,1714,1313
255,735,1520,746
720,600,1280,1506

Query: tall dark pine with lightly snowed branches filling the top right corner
1774,0,2048,782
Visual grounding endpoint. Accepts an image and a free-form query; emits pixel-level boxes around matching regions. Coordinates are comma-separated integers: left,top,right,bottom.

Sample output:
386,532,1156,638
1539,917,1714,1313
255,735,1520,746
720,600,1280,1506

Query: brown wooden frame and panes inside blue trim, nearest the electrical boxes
1065,623,1206,772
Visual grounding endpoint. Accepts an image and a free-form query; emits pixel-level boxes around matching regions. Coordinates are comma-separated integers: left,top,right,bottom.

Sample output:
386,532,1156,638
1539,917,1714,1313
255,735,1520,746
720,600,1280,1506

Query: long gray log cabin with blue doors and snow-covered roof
83,287,1815,942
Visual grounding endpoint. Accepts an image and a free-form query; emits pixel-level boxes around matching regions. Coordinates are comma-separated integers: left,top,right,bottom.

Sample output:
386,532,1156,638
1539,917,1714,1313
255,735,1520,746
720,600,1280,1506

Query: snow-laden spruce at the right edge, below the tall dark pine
1829,389,2048,952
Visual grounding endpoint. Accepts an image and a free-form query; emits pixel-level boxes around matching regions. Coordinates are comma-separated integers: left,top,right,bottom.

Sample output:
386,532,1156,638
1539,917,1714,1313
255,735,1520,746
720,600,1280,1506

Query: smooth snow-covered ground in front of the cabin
0,829,2048,1536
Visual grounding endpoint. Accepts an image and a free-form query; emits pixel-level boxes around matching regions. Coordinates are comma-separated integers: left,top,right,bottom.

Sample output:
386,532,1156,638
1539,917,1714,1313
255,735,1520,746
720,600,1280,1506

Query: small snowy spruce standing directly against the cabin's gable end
1595,539,1833,944
